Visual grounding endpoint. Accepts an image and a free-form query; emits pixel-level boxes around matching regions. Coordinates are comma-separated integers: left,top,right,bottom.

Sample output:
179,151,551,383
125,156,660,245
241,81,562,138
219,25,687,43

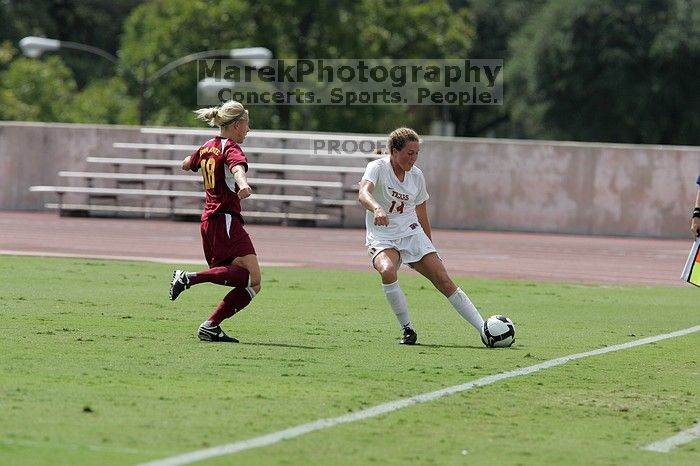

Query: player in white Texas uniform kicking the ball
358,128,484,345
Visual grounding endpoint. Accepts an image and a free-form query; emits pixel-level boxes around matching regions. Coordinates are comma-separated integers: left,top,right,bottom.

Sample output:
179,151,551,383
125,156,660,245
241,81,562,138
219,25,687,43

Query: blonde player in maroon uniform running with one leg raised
170,101,260,343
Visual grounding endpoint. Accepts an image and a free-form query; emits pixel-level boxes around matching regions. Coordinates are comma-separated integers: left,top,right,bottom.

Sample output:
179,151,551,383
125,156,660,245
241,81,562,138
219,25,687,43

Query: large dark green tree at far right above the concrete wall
507,0,700,144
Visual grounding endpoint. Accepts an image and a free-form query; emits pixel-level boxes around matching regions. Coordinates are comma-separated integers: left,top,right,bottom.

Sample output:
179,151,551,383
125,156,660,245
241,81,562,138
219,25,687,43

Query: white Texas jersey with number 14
362,157,430,245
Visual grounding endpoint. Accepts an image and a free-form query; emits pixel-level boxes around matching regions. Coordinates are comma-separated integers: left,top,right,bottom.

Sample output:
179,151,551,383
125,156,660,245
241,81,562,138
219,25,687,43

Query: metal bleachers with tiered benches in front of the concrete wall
30,128,377,226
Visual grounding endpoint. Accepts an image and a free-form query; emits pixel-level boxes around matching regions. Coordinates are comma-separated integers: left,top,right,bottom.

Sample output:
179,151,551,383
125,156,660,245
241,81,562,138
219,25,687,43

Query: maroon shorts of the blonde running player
199,214,255,267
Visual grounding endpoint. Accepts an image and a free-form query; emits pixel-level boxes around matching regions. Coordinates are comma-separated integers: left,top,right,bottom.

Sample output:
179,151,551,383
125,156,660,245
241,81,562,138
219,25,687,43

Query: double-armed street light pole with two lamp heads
19,36,272,125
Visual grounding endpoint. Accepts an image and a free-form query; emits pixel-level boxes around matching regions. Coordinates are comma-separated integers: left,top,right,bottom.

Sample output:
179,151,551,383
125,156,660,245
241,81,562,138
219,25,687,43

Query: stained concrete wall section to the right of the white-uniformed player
422,138,700,238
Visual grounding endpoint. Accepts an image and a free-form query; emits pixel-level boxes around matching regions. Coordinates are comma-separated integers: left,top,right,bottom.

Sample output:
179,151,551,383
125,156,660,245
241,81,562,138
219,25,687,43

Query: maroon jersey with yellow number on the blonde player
190,136,248,221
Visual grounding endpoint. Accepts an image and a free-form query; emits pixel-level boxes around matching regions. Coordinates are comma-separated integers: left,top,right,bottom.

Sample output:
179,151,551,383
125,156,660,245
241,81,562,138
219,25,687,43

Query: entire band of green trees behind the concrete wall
0,0,700,144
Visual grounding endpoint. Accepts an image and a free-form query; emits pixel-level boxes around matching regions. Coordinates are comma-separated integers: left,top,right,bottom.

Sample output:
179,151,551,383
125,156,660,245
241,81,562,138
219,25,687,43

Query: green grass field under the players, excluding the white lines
0,256,700,466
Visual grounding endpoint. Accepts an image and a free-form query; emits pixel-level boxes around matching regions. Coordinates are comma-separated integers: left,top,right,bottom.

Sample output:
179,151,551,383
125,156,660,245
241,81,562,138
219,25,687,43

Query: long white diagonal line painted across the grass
139,325,700,466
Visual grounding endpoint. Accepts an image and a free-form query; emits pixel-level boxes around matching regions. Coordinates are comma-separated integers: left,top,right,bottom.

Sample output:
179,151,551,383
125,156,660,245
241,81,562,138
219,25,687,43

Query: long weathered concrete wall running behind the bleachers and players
0,122,700,238
